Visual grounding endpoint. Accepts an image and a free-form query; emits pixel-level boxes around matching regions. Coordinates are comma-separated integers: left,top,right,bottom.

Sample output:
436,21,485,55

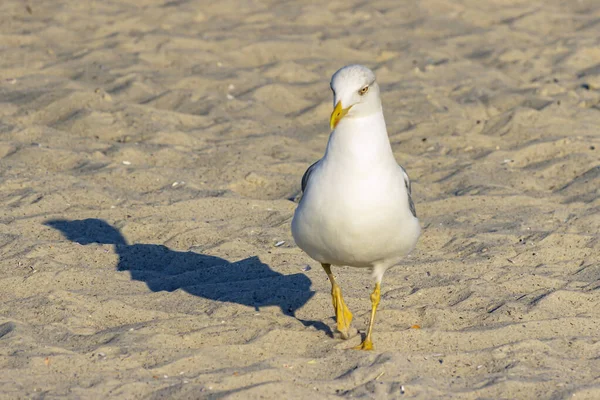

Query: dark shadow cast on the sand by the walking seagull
44,218,333,337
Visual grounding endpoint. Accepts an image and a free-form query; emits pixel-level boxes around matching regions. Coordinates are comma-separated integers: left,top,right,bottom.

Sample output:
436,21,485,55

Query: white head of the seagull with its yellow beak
329,65,381,130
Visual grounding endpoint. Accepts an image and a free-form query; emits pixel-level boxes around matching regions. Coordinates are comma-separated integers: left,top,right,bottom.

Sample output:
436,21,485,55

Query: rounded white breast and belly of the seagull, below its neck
292,163,420,267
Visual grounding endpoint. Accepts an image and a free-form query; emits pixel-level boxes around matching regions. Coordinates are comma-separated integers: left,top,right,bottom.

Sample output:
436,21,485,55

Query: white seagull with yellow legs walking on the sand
291,65,421,350
